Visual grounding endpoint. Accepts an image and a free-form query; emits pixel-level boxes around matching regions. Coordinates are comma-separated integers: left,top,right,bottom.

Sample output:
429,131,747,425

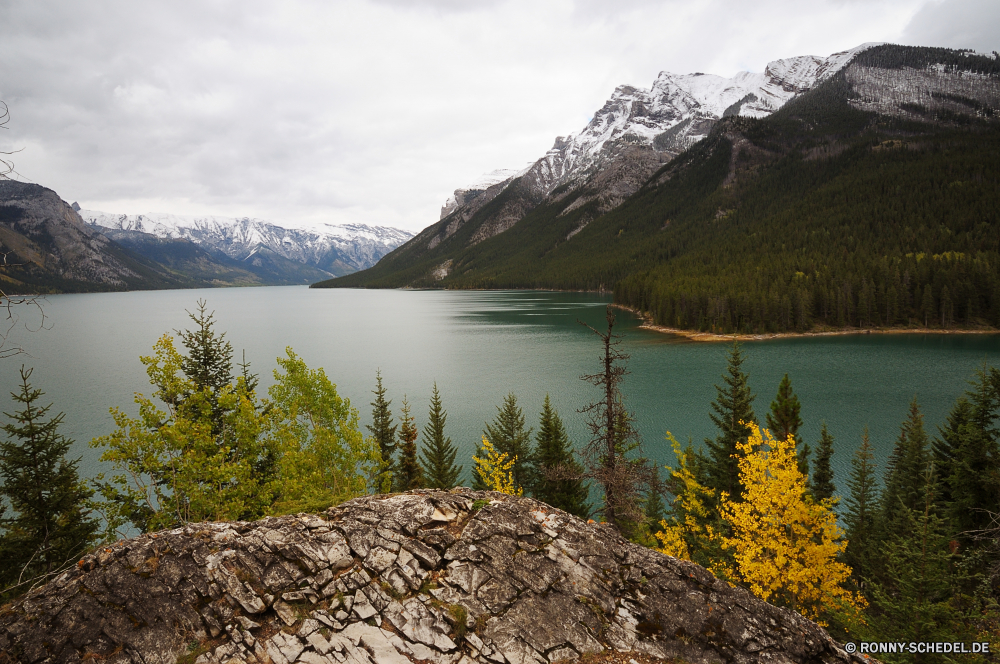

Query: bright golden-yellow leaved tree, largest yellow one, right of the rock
719,423,866,624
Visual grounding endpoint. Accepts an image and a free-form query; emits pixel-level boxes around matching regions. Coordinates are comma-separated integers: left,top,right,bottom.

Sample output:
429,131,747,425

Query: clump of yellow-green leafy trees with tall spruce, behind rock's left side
91,302,380,538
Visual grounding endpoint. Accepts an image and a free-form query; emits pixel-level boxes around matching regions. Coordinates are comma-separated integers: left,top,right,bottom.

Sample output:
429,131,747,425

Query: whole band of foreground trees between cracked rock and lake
0,301,1000,662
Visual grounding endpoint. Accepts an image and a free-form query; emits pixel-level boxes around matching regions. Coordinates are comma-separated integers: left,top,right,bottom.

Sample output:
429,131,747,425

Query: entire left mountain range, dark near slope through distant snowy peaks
0,180,412,293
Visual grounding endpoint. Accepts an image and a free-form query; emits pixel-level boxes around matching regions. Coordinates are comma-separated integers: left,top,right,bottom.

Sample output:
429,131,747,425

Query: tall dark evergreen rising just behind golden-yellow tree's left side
699,341,757,500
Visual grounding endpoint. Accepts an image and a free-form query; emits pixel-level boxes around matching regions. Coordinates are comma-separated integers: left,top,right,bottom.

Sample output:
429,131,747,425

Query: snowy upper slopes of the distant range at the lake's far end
79,210,413,274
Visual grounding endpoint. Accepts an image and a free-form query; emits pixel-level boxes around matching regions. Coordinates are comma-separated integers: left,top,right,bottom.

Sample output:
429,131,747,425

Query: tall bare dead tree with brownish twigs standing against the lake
578,306,657,536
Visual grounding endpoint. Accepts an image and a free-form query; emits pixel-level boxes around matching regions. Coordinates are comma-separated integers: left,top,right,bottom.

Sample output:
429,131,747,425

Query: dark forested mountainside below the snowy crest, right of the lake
317,46,1000,331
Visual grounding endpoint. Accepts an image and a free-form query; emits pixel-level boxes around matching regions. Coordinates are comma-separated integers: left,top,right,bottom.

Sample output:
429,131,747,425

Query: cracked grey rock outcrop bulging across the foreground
0,489,861,664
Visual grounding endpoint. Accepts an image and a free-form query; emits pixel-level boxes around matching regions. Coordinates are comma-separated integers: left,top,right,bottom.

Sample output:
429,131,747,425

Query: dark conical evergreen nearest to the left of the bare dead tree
534,394,590,519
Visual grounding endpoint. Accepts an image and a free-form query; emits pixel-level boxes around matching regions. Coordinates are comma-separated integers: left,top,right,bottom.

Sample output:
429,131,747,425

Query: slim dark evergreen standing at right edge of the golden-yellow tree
844,427,878,586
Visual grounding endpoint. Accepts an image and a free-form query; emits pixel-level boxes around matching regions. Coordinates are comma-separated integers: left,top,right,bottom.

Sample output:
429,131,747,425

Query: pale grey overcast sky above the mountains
0,0,1000,231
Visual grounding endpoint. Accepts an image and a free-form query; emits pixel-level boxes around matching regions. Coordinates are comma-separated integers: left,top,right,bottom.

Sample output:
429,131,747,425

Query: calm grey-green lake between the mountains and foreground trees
0,286,1000,498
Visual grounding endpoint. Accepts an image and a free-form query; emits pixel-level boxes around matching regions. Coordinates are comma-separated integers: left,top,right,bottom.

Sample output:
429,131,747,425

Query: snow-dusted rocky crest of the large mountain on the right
441,43,876,209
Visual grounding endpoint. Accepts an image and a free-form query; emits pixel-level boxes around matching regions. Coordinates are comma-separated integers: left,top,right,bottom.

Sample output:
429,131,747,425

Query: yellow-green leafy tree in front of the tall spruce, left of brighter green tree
90,335,275,537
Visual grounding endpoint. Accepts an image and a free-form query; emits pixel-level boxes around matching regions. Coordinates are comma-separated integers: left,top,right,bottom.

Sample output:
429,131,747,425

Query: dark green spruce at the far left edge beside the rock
0,366,98,596
